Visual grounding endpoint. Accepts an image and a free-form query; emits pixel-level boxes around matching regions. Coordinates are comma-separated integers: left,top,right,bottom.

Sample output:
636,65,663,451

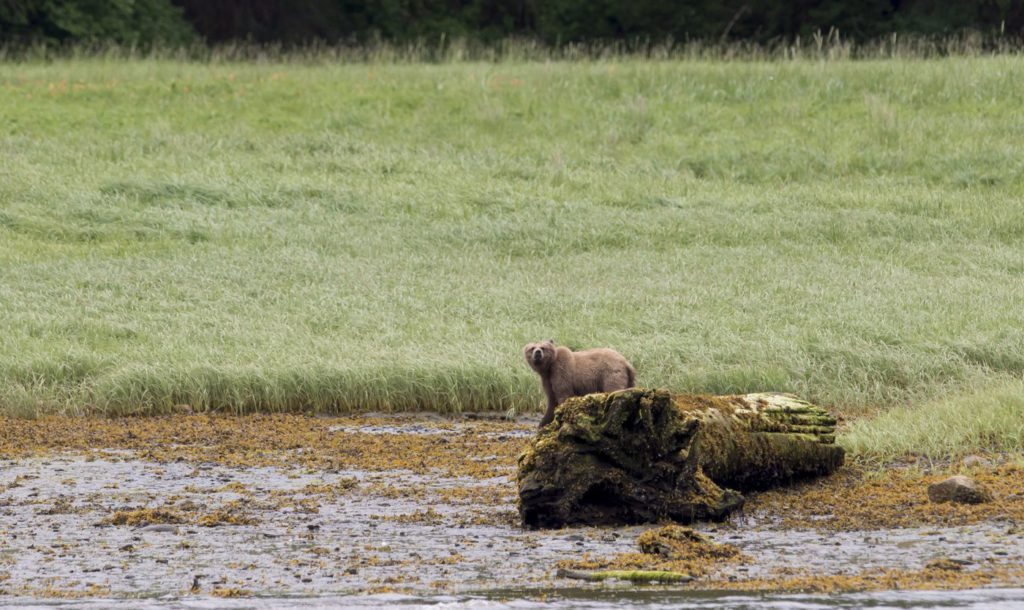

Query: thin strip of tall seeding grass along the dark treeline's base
6,29,1024,64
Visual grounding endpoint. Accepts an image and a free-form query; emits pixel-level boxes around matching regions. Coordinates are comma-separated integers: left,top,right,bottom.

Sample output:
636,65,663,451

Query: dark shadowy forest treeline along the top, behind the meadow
0,0,1024,47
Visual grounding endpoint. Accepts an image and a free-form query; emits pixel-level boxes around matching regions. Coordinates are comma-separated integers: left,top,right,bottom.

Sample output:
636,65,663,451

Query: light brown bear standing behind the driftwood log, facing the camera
522,340,637,428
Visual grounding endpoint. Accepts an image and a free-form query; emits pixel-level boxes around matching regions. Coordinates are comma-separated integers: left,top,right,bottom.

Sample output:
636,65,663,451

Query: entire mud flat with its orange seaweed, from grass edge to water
0,416,1024,608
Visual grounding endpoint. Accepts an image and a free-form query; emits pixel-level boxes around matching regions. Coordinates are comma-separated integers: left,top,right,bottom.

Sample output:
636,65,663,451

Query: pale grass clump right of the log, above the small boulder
840,380,1024,461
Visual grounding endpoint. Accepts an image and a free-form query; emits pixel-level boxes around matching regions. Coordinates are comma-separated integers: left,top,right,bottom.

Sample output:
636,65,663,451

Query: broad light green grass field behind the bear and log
0,51,1024,450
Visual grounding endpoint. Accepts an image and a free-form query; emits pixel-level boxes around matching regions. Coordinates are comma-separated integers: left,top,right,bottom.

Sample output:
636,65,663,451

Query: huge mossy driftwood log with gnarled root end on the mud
517,389,844,527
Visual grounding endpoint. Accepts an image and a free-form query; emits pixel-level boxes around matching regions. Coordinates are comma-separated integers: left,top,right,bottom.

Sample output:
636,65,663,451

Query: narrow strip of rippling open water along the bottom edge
3,587,1024,610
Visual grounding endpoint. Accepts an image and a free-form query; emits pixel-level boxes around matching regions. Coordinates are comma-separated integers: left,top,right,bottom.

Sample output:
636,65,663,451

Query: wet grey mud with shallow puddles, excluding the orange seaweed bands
0,424,1024,609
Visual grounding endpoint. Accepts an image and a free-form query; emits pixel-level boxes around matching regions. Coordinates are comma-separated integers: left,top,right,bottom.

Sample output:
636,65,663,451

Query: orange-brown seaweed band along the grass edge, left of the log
0,415,527,479
